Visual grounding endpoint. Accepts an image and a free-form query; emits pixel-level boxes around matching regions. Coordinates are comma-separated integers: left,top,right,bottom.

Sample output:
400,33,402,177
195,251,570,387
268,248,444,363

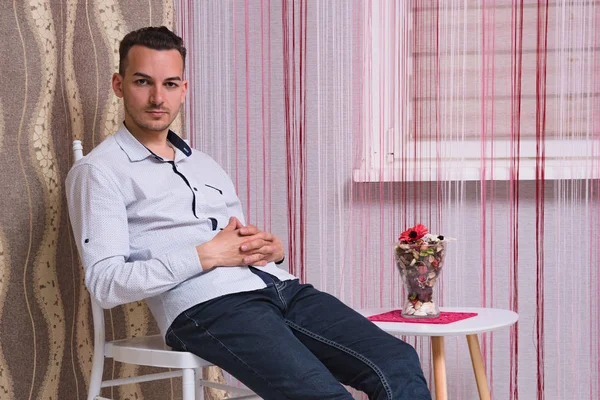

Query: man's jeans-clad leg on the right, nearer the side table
283,284,431,400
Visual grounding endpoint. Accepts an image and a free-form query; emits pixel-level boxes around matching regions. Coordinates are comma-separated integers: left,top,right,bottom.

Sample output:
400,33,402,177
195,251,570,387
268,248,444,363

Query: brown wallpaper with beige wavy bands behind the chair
0,0,195,400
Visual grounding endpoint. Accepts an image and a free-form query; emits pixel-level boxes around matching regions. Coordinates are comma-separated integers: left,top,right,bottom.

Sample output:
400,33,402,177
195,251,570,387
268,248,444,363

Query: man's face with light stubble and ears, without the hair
112,46,187,135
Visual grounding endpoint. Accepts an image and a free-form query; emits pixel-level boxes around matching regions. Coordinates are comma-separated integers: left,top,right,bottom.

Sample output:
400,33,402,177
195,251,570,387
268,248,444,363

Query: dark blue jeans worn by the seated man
166,280,431,400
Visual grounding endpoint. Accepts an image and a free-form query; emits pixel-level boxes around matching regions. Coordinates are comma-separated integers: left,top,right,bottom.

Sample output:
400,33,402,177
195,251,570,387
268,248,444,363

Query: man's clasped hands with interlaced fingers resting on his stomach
196,217,285,270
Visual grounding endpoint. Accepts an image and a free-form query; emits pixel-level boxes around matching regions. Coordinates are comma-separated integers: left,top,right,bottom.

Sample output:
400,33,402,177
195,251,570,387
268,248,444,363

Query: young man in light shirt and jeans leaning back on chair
67,27,431,400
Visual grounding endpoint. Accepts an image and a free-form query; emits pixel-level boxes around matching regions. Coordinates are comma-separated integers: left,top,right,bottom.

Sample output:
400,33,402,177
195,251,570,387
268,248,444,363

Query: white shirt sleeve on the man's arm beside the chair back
66,164,202,308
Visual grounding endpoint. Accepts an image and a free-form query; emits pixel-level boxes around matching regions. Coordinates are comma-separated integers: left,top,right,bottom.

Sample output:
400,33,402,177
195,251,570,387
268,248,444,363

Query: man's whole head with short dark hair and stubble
112,27,187,139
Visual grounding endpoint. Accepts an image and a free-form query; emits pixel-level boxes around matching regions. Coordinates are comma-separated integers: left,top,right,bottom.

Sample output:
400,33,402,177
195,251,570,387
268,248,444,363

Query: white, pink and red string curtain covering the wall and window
175,0,600,400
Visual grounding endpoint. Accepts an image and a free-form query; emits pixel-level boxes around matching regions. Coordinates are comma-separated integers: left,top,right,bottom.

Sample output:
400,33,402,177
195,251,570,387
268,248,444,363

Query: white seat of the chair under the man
104,335,213,368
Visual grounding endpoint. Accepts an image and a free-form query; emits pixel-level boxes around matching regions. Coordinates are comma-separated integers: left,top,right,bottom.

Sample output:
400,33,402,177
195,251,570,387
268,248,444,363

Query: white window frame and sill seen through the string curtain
353,1,600,182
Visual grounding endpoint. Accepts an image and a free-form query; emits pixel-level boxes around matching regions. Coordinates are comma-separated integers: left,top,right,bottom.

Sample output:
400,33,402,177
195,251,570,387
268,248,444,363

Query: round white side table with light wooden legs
358,307,519,400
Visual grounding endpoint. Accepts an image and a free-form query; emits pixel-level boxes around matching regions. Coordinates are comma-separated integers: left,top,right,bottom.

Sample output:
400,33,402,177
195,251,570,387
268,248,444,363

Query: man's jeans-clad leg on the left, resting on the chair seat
167,282,352,400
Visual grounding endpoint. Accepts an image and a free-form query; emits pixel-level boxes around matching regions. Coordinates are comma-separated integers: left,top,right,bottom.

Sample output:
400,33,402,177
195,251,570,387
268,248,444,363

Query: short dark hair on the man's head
119,26,186,76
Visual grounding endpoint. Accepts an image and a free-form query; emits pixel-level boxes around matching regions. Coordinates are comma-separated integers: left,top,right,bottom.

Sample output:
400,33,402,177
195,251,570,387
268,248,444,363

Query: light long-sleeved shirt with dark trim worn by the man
66,125,296,335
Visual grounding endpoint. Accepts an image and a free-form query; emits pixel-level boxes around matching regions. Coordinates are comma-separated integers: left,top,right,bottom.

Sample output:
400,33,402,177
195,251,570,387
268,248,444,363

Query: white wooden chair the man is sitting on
73,140,261,400
